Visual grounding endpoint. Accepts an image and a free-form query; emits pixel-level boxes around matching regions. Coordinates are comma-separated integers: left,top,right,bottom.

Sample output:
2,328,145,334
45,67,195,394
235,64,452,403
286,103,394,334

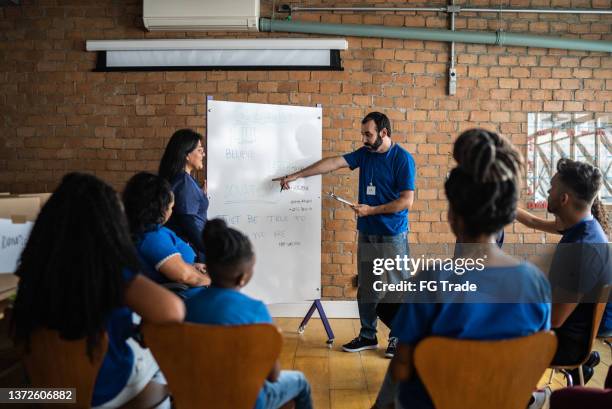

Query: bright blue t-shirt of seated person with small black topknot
185,287,272,409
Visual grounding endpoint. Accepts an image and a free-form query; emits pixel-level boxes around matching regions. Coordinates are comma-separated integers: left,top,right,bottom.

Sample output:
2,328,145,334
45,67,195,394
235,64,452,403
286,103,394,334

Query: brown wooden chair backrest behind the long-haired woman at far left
24,329,108,408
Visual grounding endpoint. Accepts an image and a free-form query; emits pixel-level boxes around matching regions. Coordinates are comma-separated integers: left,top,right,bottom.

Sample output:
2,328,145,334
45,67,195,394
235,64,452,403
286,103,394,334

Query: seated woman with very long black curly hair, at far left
13,173,185,408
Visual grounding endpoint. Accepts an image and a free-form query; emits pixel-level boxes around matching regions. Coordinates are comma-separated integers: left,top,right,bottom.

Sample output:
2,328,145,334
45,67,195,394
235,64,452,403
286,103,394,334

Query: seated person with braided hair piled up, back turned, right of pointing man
384,129,550,408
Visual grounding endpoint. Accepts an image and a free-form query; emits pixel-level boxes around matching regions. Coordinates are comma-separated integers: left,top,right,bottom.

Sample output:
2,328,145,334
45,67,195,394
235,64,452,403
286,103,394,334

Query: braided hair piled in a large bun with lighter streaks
444,128,523,236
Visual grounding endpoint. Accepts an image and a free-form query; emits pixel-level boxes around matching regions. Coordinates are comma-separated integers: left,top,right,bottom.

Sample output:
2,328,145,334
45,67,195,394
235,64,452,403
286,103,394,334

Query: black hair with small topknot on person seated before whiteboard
202,219,255,281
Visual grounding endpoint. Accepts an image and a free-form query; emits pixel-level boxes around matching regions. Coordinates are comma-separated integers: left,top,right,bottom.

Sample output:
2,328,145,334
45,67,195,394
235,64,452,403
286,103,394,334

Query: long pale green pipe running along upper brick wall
259,18,612,53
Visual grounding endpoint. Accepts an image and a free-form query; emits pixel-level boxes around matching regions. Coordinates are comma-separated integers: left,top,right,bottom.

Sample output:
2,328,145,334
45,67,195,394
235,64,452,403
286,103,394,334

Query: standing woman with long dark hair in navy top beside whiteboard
159,129,208,263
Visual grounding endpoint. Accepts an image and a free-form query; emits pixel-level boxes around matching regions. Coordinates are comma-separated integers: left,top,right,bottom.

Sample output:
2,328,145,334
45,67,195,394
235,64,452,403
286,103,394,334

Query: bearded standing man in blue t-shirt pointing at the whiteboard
274,112,416,358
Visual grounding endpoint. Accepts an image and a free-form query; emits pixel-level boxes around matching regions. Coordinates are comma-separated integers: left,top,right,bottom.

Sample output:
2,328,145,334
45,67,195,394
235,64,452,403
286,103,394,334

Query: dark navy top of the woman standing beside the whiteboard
166,172,208,262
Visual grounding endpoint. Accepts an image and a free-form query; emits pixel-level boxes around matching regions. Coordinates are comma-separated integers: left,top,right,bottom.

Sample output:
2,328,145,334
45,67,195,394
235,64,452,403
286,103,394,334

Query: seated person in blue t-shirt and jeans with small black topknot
186,219,312,409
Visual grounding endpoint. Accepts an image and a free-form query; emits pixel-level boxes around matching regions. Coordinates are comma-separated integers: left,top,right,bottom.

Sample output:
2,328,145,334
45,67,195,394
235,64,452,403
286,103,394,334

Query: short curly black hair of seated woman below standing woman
123,172,173,237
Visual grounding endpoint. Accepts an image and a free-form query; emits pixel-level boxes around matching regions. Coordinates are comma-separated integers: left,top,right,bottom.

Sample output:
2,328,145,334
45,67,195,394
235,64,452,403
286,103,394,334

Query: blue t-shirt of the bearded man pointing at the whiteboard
344,143,416,236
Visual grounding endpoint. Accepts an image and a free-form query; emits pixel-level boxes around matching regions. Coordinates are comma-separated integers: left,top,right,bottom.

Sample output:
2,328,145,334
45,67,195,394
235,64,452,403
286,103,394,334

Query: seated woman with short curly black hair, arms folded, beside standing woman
123,172,210,297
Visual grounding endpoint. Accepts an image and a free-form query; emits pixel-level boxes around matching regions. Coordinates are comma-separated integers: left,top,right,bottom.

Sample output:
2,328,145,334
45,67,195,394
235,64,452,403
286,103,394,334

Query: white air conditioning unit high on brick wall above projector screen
142,0,259,31
